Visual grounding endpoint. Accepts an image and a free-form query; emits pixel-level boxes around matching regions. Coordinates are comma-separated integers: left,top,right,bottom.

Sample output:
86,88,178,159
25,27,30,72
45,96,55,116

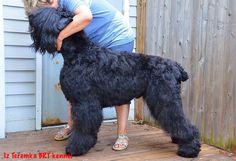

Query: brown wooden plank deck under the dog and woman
0,122,236,161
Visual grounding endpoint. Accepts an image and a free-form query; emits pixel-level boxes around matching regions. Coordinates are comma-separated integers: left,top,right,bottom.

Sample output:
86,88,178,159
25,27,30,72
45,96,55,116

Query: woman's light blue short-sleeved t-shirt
59,0,134,48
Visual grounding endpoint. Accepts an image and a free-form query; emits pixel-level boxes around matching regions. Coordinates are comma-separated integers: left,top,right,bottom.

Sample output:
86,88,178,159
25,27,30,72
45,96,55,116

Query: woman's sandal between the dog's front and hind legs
112,134,129,151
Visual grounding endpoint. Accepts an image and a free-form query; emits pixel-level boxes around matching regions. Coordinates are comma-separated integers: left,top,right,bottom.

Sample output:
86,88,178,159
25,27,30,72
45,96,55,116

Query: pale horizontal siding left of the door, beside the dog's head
3,0,36,132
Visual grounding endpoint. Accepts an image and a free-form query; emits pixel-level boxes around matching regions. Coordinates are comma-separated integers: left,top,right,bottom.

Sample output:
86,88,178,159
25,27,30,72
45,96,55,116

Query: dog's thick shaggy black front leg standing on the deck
66,100,103,156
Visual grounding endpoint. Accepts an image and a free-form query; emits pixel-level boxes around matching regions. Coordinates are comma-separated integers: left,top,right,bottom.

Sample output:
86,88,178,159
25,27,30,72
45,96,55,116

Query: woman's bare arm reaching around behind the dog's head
56,5,93,51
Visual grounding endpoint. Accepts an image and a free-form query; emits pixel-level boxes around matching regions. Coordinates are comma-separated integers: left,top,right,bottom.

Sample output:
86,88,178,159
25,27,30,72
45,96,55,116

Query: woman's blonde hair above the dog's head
23,0,52,15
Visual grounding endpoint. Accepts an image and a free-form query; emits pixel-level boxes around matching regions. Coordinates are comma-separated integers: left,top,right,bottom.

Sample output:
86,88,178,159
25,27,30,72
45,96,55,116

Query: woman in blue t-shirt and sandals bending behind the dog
24,0,134,150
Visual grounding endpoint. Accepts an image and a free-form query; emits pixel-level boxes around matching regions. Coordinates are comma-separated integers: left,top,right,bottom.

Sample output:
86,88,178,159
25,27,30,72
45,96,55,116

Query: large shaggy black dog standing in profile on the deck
29,8,200,157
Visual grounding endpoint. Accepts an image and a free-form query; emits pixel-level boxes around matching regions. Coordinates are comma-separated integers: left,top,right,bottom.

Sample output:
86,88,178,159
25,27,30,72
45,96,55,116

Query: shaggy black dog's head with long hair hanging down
29,7,74,55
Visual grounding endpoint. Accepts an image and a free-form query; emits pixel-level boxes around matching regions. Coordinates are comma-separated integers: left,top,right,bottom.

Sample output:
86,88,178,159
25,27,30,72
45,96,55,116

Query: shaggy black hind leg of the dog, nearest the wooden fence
144,79,201,157
